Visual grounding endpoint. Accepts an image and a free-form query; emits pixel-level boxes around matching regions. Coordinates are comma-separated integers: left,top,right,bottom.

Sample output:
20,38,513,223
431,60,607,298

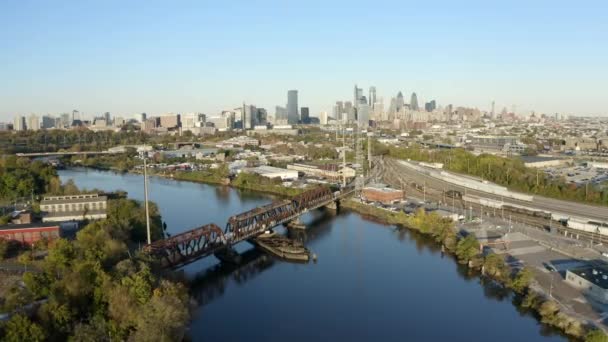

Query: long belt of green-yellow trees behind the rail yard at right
375,144,608,205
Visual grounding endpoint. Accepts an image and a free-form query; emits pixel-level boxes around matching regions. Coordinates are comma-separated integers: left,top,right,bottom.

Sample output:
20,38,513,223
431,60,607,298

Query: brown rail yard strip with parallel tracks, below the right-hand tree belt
383,158,608,222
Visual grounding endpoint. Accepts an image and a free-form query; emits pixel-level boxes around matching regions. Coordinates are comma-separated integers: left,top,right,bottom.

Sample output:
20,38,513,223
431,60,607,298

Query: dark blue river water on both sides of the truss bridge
59,169,565,342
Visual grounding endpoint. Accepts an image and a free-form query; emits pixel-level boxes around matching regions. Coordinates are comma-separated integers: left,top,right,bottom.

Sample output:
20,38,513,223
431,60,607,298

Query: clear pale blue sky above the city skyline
0,0,608,121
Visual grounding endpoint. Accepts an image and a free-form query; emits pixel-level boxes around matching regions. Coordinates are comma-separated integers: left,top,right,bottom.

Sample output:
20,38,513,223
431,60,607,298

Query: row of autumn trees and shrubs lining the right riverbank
341,200,608,341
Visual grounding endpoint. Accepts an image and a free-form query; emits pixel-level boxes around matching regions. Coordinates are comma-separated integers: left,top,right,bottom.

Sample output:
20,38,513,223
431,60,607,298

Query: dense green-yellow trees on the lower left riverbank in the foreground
0,200,189,341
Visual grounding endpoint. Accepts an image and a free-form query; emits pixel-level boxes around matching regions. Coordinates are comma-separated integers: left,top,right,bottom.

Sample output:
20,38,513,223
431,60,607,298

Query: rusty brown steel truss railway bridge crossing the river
145,187,355,268
